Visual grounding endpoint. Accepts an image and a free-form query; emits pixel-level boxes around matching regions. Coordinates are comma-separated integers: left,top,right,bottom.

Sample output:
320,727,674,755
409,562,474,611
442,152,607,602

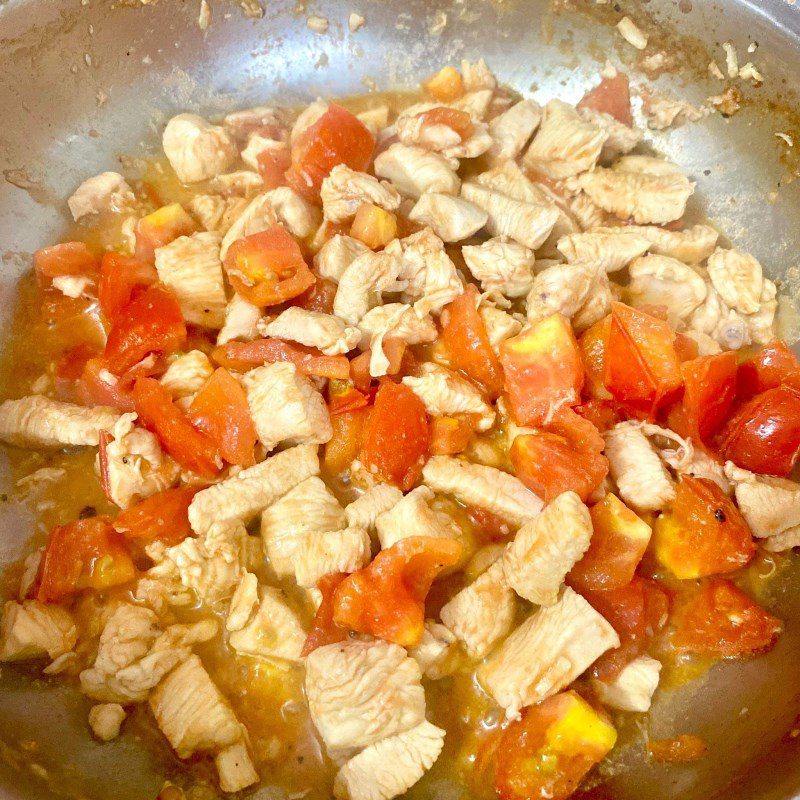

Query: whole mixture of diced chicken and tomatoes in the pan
0,62,800,800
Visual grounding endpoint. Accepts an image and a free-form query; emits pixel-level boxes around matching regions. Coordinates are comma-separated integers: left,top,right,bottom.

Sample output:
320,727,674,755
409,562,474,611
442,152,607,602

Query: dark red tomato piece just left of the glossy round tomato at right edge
681,350,737,442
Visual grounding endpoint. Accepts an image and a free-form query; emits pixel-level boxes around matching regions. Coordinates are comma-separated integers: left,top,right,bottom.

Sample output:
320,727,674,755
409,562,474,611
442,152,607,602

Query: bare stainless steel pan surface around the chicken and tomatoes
0,0,800,800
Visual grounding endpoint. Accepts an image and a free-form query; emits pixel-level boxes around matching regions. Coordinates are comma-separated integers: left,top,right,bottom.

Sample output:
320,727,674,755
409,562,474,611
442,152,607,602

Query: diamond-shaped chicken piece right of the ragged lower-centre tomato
440,561,517,659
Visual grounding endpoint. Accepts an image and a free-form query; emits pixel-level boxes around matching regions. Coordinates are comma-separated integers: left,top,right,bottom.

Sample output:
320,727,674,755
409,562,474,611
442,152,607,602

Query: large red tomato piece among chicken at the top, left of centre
286,103,375,201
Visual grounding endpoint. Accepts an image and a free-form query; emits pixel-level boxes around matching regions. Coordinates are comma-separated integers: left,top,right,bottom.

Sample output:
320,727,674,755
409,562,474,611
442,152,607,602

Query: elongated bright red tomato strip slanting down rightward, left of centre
133,378,222,478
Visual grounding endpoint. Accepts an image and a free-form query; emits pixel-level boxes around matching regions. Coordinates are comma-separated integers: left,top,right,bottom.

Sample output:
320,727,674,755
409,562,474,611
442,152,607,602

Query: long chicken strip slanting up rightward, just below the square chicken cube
189,445,319,534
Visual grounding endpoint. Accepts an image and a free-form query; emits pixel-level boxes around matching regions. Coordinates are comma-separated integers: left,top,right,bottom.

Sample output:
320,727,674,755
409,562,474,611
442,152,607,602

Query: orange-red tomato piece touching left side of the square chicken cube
187,367,258,467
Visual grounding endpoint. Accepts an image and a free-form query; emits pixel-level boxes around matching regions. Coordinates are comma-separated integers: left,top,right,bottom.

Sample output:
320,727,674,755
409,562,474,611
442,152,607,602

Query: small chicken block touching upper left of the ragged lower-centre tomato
294,528,372,587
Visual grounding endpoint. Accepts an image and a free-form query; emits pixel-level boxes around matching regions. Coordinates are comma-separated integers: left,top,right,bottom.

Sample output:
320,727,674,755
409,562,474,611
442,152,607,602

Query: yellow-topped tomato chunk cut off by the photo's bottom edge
495,691,617,800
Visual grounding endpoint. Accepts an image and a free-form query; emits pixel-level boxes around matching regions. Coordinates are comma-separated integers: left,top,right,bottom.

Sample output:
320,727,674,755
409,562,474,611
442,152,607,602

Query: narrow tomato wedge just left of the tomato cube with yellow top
442,284,503,398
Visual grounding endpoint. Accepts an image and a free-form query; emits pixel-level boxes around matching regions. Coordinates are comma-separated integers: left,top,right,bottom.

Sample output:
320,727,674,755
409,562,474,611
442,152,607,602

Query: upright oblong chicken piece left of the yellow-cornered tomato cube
503,492,592,606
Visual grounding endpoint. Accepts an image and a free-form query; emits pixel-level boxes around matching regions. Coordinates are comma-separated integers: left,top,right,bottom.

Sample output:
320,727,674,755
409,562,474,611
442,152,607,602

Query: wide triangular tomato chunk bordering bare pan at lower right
672,578,783,657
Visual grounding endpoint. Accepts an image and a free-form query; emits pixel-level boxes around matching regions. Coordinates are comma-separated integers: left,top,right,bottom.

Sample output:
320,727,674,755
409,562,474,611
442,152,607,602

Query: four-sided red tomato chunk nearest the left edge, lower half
37,517,136,603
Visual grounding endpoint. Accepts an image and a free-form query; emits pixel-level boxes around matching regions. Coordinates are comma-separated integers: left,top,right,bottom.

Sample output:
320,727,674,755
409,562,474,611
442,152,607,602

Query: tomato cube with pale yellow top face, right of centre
500,314,583,425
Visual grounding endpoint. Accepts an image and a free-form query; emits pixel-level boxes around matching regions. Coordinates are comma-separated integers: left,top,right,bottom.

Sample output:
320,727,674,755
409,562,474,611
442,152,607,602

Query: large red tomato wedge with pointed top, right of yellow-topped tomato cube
605,303,683,419
